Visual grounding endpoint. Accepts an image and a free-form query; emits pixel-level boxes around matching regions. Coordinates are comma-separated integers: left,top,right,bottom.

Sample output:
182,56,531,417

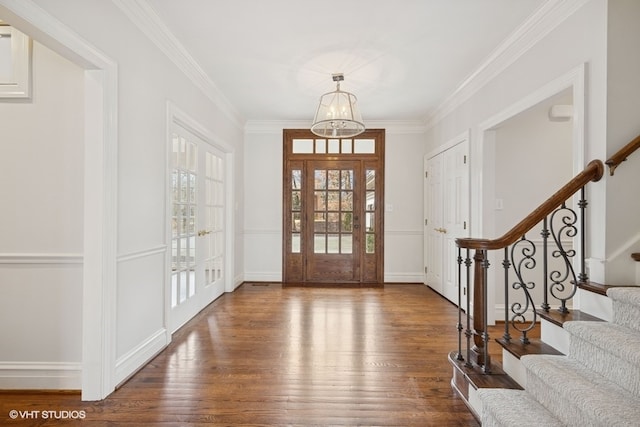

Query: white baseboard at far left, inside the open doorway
0,362,82,390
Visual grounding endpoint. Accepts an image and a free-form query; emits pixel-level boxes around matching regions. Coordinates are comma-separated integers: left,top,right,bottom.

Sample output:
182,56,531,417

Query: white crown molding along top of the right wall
425,0,590,129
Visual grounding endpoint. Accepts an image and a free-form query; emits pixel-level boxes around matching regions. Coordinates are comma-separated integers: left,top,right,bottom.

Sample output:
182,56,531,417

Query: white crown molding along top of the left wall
112,0,245,129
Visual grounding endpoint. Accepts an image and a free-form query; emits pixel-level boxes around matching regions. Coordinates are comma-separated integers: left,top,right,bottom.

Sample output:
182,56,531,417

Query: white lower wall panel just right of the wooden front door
384,230,424,283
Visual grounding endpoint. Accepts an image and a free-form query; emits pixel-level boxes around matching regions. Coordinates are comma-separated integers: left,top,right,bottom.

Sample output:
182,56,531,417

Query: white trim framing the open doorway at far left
0,0,118,400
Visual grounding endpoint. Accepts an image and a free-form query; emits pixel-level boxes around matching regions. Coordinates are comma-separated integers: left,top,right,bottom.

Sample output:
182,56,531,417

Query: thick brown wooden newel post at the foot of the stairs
470,249,491,372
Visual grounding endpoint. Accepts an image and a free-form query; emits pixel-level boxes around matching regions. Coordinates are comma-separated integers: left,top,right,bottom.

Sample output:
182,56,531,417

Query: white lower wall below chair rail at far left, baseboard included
0,254,82,389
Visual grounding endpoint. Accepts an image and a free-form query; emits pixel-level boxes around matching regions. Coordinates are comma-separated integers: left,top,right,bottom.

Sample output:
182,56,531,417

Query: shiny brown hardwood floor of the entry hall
0,283,490,426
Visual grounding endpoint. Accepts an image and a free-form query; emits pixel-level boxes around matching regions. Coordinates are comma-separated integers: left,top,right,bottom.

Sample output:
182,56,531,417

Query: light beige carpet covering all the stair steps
477,287,640,427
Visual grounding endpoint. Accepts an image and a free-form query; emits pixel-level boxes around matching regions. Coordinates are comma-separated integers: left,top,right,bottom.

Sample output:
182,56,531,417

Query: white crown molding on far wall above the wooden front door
244,120,427,134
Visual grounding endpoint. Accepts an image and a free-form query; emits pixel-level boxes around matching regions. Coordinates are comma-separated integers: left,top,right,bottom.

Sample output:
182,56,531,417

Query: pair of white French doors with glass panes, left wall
168,124,225,333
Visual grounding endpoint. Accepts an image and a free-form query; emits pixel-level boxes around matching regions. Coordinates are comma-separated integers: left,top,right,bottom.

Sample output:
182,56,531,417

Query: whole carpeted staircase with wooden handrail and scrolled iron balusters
449,136,640,427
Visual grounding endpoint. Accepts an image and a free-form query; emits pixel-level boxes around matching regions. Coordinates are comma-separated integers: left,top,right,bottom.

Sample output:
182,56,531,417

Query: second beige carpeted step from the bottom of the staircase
520,355,640,427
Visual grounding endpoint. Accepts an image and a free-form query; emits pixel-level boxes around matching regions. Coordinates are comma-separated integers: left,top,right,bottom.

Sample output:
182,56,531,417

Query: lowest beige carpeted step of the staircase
477,388,564,427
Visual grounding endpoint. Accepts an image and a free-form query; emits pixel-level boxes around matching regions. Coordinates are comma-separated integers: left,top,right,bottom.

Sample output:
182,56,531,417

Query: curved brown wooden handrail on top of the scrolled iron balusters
456,160,604,254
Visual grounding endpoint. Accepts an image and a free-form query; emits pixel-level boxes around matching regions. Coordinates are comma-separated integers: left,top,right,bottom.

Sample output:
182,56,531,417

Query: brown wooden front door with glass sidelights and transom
283,130,384,283
